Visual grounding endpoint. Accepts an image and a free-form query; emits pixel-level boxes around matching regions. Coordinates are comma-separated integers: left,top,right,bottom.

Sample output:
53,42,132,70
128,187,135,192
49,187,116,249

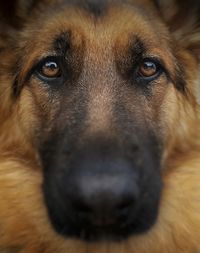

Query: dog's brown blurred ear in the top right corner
155,0,200,60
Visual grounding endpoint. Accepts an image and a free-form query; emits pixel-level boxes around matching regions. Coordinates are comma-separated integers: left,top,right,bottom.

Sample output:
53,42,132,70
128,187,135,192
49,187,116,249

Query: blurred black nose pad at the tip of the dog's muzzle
65,158,139,227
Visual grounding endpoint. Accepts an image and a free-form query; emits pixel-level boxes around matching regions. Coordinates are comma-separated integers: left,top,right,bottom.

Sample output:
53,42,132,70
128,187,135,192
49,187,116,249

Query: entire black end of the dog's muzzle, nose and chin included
43,142,162,241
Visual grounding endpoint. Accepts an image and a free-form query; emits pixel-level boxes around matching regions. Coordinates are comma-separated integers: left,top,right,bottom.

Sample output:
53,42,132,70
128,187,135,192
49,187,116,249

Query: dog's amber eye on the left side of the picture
40,61,61,78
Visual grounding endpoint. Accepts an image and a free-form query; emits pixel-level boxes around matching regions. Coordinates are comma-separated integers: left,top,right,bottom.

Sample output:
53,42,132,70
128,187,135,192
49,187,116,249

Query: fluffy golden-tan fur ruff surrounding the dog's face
0,0,200,253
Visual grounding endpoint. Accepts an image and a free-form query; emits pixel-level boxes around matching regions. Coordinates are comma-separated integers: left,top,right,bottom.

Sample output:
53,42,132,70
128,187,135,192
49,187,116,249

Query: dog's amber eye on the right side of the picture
138,60,160,78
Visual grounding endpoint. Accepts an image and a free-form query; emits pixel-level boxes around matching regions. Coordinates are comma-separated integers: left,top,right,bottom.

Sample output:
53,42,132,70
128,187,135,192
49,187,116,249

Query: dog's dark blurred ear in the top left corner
0,0,37,28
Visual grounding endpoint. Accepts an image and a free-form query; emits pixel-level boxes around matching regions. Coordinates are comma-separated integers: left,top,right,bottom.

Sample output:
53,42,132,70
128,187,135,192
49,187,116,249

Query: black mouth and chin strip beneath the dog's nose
50,203,158,242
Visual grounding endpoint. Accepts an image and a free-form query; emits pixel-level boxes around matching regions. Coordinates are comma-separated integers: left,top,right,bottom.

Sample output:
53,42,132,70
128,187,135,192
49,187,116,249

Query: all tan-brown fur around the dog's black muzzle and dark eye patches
0,0,200,253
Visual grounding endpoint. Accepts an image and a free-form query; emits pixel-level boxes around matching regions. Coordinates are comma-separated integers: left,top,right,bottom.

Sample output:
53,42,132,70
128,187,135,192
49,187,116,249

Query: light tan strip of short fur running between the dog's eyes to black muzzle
83,36,118,135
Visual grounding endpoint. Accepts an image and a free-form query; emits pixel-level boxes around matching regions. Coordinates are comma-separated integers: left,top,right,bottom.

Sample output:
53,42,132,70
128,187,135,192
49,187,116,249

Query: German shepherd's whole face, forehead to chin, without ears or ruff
0,0,199,247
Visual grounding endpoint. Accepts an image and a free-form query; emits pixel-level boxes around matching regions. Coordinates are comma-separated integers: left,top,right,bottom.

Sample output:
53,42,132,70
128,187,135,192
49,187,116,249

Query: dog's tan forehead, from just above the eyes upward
20,0,171,77
